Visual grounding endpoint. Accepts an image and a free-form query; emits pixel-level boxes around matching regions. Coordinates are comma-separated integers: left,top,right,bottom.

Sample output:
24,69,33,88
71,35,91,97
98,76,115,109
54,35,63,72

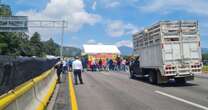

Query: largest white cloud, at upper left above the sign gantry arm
16,0,101,39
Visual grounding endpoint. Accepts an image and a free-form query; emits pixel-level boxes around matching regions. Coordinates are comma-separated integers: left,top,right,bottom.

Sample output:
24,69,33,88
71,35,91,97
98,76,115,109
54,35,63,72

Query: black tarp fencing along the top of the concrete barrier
0,56,58,95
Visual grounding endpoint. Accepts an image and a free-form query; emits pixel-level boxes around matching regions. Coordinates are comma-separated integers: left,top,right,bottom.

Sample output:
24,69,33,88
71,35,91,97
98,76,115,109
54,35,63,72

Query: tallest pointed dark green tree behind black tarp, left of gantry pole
30,32,44,57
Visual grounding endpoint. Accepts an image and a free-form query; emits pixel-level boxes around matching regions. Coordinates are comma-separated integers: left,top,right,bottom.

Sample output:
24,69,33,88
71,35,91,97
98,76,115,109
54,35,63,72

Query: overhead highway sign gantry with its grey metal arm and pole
0,16,68,58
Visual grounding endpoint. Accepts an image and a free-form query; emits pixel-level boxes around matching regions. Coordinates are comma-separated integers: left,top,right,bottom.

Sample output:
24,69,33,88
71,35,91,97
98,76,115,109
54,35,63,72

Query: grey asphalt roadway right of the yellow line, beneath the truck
75,72,208,110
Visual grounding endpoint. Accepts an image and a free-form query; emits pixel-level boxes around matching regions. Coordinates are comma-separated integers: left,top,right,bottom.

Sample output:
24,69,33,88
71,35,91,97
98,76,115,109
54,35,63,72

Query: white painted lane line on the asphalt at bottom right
155,91,208,110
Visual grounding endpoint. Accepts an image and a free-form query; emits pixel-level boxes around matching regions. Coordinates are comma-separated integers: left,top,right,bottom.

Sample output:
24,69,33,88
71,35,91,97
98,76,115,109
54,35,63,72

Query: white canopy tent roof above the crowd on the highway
83,44,121,55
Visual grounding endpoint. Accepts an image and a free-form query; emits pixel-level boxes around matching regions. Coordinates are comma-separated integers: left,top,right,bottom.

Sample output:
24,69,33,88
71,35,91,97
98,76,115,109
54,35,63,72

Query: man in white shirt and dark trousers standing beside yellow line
72,57,83,85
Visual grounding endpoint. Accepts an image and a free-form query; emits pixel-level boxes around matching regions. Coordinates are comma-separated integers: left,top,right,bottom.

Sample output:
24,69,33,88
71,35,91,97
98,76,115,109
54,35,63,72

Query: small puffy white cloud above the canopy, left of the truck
106,20,138,37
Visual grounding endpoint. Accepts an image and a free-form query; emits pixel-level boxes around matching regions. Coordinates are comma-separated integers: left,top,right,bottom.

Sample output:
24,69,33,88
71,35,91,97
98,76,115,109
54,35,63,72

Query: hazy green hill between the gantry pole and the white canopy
63,47,81,57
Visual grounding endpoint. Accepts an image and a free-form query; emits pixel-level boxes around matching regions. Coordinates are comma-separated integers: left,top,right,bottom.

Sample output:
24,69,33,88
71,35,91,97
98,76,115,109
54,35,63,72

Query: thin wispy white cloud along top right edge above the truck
140,0,208,15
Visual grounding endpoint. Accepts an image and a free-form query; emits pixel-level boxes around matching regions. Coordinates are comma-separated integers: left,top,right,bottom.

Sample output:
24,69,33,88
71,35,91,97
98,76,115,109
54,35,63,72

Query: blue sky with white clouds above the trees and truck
3,0,208,48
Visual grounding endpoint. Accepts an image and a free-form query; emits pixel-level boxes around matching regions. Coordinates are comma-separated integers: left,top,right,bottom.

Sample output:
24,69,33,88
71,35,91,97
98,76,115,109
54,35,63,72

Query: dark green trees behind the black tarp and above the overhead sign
0,5,60,57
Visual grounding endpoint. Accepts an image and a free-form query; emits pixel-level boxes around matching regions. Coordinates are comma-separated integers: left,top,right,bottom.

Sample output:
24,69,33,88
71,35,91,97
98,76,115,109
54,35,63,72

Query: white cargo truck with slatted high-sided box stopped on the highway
130,21,202,84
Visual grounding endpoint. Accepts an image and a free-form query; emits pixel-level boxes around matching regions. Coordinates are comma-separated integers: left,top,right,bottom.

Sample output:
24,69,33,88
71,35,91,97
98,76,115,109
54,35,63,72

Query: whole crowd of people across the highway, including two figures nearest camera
55,57,135,84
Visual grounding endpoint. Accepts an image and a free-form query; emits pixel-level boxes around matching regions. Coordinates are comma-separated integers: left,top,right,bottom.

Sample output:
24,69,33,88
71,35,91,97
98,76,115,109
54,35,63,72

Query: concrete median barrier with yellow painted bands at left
0,69,57,110
